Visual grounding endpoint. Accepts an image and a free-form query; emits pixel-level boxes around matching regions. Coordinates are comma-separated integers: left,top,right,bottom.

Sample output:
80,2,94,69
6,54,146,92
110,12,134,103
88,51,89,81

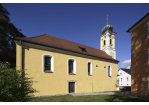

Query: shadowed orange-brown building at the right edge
127,13,149,96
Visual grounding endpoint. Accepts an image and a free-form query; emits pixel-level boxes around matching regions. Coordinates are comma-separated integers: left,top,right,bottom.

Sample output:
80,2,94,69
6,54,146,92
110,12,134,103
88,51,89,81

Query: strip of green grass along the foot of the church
29,94,146,102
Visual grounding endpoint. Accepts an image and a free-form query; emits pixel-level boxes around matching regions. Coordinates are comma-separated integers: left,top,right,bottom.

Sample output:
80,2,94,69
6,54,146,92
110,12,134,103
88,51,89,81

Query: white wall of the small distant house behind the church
118,69,131,86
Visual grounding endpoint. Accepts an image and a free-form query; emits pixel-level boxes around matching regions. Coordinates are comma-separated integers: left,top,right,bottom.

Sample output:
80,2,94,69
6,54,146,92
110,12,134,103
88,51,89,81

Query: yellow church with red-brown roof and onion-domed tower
12,18,119,96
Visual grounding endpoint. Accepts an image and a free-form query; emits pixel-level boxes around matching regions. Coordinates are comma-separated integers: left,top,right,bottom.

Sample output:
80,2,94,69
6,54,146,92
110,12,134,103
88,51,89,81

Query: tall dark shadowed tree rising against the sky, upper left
0,4,25,67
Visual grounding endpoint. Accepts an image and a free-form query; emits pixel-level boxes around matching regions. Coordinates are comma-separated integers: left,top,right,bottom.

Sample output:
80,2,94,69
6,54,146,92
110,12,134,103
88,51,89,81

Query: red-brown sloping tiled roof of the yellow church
12,34,119,62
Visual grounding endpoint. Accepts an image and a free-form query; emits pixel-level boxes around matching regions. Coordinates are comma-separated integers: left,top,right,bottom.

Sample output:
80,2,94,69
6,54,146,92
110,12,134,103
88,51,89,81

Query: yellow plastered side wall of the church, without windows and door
16,44,118,96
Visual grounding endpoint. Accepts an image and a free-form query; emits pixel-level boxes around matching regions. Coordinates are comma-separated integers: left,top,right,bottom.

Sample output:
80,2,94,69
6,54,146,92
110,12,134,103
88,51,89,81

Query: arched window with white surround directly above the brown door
68,58,76,75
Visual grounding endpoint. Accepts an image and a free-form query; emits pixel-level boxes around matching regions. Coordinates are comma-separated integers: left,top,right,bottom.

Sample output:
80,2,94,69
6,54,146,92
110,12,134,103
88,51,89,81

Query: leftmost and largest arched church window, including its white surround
42,54,54,73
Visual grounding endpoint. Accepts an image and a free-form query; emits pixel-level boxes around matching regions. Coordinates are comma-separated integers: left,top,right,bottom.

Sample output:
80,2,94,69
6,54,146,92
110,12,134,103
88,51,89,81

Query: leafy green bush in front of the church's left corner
0,64,38,102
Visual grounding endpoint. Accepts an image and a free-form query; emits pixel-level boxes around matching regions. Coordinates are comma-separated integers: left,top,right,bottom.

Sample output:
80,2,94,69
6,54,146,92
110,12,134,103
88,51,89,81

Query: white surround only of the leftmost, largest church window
42,54,54,73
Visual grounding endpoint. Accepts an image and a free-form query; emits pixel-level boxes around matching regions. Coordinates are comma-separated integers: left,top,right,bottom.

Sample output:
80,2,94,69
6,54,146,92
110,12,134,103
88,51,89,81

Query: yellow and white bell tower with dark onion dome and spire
99,15,117,59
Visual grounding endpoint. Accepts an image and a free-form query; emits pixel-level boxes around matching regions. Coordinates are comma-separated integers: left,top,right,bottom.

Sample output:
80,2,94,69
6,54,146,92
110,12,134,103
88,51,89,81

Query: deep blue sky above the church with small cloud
2,3,149,68
